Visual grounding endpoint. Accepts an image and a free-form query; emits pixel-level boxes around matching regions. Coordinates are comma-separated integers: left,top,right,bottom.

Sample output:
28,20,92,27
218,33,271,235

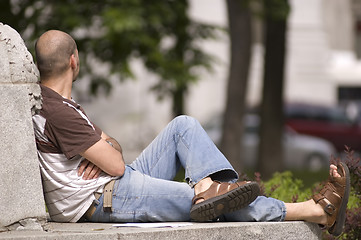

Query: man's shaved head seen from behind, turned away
35,30,77,80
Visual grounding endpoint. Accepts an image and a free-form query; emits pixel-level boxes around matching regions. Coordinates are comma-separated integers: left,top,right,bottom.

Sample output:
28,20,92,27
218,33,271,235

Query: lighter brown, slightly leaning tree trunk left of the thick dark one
220,0,251,176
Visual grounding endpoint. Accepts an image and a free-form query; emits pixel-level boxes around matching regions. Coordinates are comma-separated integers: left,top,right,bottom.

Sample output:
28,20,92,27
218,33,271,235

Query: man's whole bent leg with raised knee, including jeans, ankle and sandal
131,116,259,221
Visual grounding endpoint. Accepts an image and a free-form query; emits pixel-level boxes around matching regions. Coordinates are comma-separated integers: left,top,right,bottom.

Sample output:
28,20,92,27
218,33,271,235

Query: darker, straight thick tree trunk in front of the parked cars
256,0,288,179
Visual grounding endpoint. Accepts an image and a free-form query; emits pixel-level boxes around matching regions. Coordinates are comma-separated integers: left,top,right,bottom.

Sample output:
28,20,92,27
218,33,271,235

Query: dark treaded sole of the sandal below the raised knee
190,182,260,222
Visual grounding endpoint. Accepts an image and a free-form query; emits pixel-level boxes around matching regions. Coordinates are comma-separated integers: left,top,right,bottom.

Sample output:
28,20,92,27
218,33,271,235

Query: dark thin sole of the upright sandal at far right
329,162,350,236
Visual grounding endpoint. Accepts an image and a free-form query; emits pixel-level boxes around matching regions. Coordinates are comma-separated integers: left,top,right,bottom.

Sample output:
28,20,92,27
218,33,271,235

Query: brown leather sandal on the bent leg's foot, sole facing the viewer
190,181,260,222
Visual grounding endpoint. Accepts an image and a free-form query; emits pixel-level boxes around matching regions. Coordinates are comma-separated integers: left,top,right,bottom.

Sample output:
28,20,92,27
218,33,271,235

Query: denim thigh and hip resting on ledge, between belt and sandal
90,166,194,222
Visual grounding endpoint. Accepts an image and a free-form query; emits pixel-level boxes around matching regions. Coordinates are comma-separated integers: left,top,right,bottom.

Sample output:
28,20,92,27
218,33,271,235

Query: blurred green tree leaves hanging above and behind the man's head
0,0,216,116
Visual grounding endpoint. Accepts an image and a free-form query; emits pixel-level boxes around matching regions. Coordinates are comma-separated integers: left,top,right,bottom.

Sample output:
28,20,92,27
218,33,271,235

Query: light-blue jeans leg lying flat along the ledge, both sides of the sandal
90,184,286,222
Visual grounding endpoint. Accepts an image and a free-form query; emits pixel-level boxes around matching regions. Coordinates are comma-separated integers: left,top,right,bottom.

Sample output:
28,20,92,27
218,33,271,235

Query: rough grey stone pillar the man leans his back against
0,23,46,230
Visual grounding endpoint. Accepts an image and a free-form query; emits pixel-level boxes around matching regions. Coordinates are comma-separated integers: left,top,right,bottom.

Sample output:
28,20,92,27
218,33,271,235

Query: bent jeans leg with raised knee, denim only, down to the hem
131,116,238,186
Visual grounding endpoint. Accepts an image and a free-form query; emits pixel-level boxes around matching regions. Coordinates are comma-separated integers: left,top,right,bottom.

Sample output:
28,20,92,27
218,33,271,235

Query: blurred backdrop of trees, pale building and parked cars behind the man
0,0,361,178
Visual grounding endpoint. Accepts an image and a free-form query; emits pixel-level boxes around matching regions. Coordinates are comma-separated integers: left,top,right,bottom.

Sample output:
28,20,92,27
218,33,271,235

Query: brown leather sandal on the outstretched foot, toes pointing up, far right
312,162,350,236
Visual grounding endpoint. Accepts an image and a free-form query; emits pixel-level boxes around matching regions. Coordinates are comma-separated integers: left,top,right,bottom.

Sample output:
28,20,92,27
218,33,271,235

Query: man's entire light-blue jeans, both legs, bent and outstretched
90,116,286,222
